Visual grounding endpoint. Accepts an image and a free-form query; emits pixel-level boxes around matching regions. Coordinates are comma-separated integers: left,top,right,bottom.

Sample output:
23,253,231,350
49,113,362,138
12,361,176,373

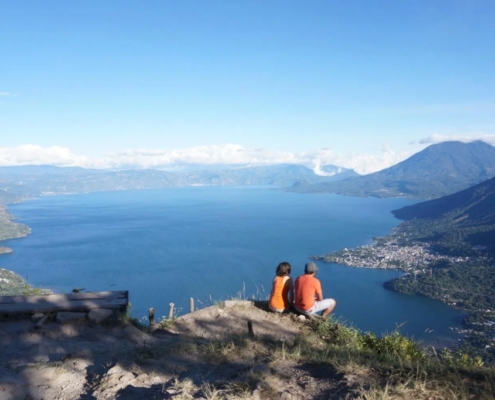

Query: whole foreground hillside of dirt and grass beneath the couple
0,301,495,400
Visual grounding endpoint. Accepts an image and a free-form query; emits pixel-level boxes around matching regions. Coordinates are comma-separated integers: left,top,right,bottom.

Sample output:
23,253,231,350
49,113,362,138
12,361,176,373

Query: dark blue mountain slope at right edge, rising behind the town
392,178,495,254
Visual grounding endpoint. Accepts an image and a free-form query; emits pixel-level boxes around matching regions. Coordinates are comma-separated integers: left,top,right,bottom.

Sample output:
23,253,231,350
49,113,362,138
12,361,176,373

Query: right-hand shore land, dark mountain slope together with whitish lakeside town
313,178,495,363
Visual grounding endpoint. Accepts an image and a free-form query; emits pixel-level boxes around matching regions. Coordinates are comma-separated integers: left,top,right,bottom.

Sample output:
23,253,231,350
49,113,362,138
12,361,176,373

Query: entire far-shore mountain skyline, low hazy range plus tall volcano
0,141,495,203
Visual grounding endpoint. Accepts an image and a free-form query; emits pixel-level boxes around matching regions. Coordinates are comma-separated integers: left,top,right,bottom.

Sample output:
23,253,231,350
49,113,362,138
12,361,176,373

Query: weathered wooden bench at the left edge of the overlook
0,290,129,314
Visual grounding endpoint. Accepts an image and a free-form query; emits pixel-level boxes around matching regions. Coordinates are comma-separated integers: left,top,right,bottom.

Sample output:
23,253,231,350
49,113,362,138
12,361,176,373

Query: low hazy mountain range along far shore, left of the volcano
0,164,357,203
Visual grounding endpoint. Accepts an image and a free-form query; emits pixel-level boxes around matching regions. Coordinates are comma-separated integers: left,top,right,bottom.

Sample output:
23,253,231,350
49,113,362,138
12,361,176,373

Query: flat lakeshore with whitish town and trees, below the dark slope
312,224,495,359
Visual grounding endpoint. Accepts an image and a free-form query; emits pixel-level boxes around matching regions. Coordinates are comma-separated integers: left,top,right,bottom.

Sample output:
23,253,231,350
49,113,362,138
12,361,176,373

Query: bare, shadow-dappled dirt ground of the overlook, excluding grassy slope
0,303,356,400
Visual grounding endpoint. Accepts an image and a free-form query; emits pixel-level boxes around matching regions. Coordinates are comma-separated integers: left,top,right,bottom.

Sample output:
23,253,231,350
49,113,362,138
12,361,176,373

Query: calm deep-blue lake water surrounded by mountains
0,187,461,345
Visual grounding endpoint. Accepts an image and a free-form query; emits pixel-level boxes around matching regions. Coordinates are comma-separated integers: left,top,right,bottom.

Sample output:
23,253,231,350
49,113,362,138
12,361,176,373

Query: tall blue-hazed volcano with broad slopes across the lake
289,141,495,199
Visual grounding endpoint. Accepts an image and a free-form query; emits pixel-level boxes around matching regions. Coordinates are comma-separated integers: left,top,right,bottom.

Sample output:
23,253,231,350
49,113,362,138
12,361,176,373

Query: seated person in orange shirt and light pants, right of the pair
294,262,337,317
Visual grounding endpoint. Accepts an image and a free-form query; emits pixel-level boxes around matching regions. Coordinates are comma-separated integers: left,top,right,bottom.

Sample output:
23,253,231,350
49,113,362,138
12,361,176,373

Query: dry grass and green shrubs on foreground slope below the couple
154,319,495,400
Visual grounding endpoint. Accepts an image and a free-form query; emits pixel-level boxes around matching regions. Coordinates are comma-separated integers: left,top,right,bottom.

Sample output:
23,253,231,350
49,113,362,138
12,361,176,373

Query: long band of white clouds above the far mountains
0,144,410,174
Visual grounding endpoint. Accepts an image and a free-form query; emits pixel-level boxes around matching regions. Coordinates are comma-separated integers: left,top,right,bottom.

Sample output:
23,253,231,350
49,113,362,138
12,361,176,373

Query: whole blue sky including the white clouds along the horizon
0,0,495,173
